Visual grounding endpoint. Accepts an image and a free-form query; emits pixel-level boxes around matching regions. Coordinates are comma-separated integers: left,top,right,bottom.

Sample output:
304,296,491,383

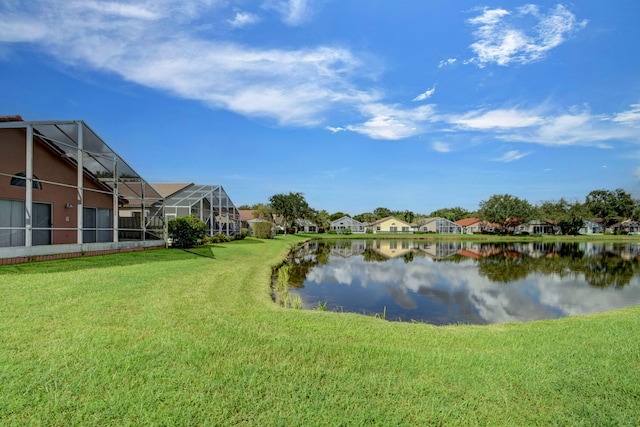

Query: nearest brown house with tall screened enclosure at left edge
0,116,165,263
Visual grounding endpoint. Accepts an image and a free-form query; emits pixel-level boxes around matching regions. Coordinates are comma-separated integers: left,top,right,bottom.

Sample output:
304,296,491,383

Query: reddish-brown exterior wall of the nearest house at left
0,129,113,244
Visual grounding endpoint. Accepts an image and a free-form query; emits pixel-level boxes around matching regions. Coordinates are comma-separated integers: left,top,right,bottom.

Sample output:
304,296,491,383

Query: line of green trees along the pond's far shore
239,188,640,234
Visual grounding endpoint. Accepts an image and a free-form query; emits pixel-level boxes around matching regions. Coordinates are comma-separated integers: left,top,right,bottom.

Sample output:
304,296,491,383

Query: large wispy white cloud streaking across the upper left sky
0,0,378,126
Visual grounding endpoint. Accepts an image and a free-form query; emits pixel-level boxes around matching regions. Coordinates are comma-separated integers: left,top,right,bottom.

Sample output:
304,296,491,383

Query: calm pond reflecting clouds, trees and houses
274,239,640,325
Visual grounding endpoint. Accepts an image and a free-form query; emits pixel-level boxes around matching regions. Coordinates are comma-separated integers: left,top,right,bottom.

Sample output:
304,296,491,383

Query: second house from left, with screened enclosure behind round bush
153,183,241,236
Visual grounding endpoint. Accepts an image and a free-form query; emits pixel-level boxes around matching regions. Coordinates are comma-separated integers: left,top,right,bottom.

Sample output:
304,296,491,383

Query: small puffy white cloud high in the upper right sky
467,5,587,67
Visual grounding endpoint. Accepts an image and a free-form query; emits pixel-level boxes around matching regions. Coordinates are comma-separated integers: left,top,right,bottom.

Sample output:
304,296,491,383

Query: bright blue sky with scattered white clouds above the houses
0,0,640,215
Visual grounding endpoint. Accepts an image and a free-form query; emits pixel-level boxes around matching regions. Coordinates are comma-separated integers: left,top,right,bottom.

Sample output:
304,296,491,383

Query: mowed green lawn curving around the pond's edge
0,236,640,426
